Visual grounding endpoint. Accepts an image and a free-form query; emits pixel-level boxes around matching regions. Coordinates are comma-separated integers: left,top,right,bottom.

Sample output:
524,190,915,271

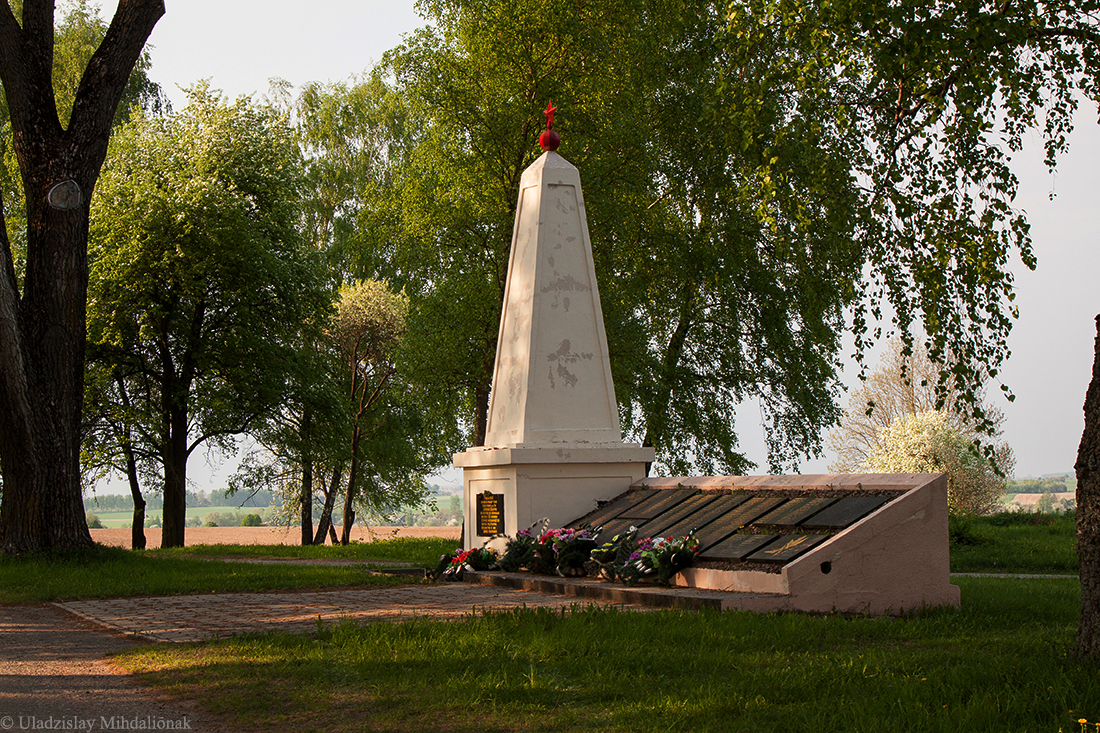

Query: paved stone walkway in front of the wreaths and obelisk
54,582,644,642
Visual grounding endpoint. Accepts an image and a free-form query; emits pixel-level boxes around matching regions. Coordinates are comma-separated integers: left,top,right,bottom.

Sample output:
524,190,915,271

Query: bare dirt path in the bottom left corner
0,605,243,733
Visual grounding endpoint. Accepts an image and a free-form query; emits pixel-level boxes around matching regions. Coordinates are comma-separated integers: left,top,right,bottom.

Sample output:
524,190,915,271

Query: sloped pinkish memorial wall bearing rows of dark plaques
570,473,959,614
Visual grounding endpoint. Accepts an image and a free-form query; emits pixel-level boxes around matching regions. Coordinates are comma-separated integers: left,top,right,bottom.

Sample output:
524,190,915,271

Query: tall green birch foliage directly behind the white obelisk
342,0,861,473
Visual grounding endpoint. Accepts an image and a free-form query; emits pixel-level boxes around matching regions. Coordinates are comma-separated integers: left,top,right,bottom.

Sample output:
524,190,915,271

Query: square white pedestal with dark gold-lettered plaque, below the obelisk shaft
454,442,653,548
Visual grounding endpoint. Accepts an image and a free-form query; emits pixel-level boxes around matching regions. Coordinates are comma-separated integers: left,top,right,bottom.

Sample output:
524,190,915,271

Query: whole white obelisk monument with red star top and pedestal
454,105,653,548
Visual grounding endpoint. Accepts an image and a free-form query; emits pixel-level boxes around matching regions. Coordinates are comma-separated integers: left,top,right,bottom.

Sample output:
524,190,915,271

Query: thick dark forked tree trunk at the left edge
0,0,164,554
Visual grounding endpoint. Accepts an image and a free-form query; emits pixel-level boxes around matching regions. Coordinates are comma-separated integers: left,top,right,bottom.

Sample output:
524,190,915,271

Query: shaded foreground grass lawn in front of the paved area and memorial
116,578,1100,733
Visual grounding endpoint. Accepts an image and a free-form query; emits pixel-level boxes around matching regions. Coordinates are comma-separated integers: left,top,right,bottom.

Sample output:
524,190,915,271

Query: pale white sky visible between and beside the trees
88,0,1100,492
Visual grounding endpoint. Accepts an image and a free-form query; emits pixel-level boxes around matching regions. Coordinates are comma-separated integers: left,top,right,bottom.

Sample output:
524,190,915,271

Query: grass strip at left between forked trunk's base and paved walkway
0,538,454,603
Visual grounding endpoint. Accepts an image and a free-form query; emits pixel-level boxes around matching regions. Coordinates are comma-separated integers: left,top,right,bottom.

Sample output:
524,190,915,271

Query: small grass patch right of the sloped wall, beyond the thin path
952,513,1078,575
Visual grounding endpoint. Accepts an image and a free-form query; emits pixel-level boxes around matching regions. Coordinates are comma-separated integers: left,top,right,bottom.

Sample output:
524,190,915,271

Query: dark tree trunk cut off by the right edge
1074,316,1100,661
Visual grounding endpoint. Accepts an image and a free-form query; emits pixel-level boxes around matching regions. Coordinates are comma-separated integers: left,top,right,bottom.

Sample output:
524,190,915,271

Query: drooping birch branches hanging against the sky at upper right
725,0,1100,444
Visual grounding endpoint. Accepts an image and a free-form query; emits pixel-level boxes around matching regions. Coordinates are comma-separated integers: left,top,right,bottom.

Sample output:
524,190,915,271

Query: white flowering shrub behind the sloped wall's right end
864,411,1005,514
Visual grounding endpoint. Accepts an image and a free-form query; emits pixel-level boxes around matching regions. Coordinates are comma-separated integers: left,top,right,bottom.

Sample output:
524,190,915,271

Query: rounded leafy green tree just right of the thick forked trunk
85,86,330,537
